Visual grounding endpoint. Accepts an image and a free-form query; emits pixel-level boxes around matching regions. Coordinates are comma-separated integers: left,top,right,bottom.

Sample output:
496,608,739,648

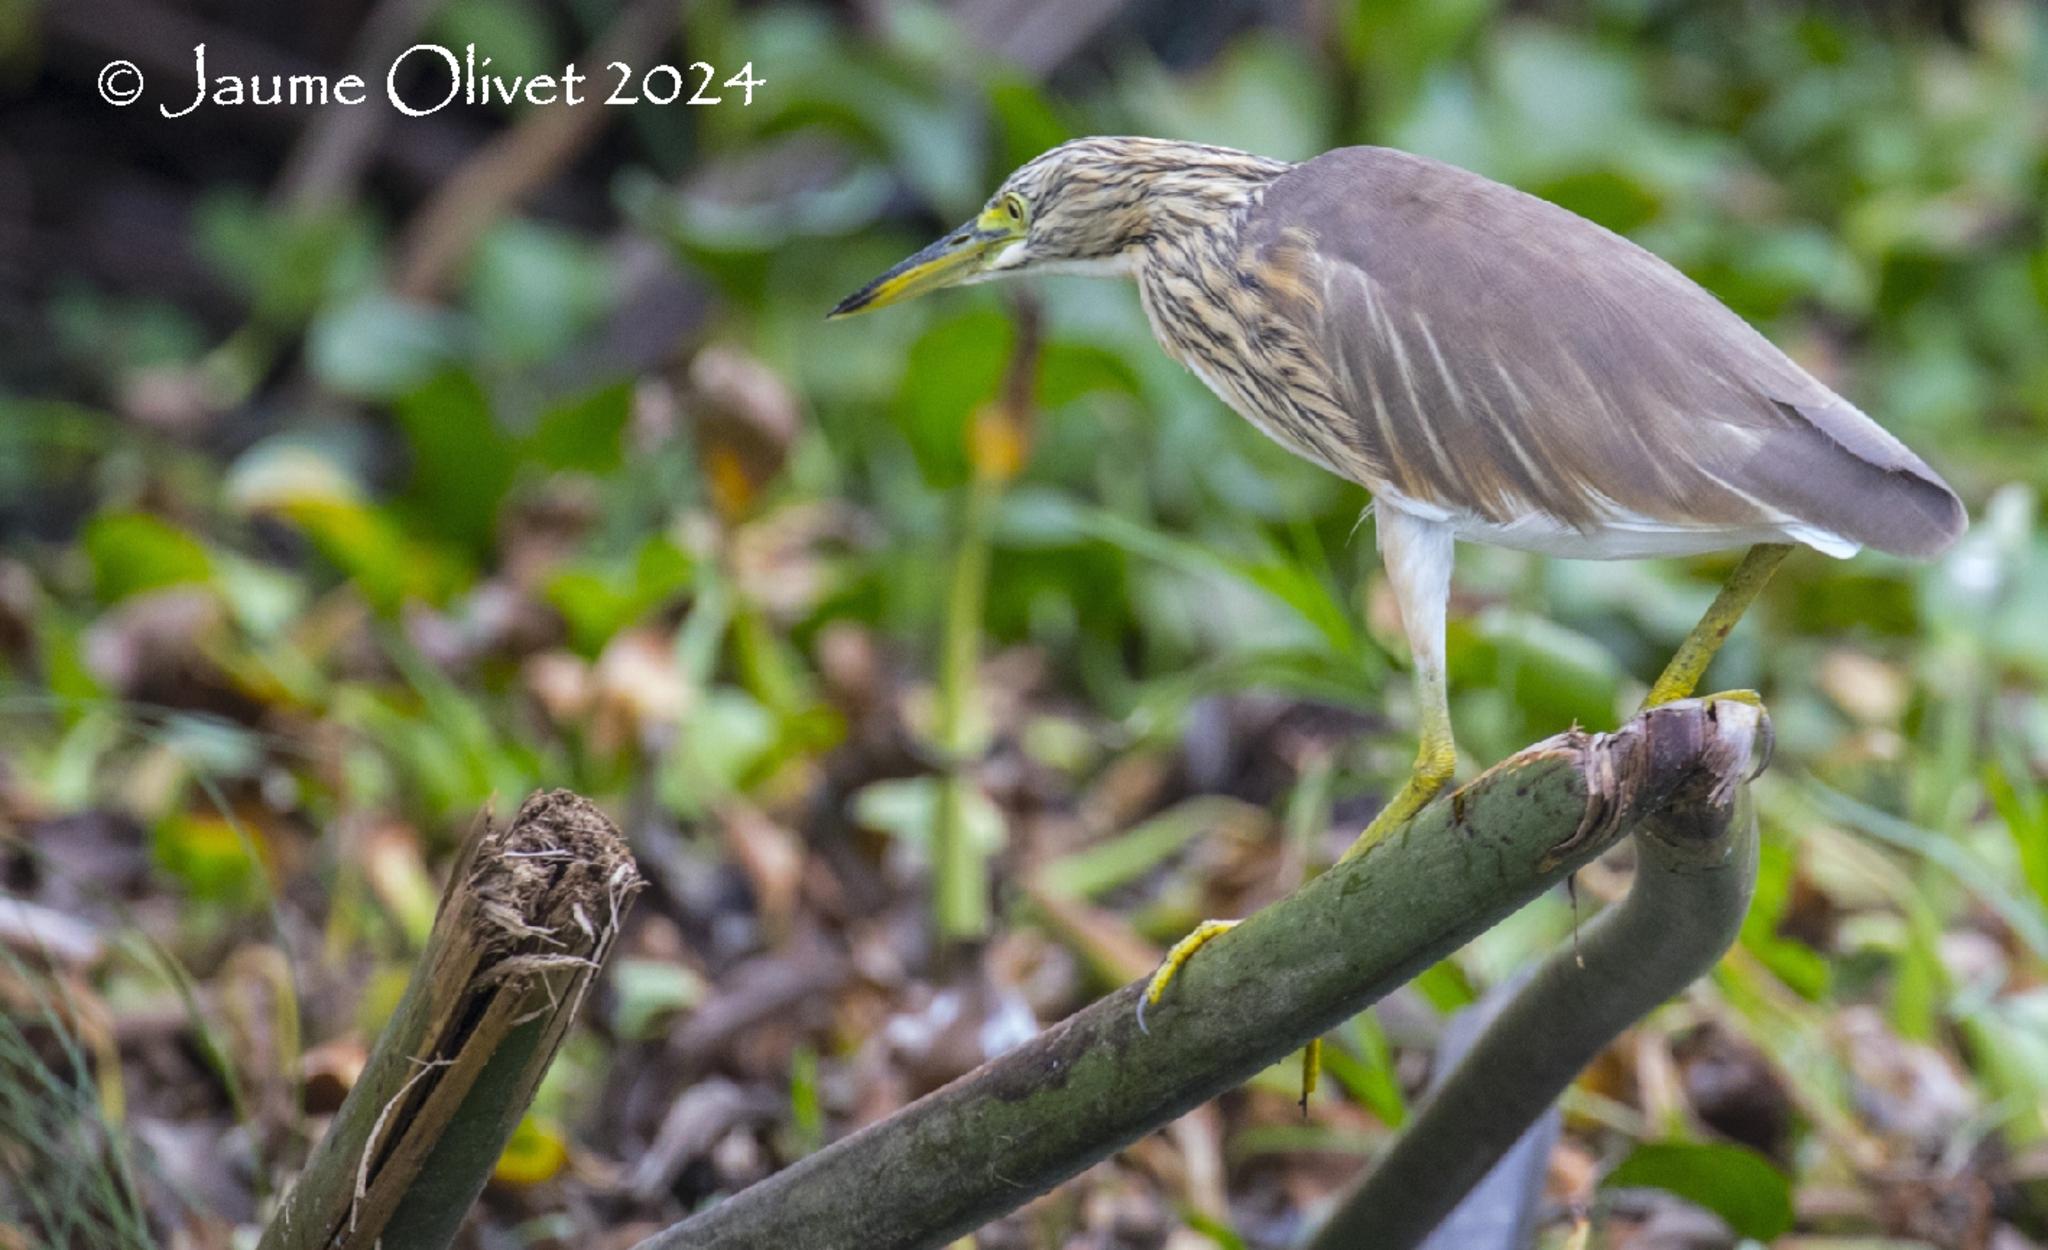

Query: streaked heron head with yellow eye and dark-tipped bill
829,137,1286,318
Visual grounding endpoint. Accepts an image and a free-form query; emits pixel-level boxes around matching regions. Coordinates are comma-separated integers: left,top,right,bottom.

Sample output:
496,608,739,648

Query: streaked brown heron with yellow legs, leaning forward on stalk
831,137,1964,1036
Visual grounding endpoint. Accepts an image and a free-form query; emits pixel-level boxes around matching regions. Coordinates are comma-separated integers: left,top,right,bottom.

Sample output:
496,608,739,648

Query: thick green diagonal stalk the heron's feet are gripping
637,701,1757,1250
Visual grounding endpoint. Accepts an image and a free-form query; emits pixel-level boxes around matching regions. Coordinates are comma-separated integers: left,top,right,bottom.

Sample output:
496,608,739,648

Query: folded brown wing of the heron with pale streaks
1241,148,1964,555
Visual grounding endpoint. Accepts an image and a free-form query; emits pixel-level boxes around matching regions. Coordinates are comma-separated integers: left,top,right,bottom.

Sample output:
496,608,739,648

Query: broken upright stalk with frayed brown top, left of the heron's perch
260,791,641,1250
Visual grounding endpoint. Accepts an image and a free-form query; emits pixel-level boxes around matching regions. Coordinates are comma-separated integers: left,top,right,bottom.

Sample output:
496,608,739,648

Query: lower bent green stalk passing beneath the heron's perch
1309,703,1761,1250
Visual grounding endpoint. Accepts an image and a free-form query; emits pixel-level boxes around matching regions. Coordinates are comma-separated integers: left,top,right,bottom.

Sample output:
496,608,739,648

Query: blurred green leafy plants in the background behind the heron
0,0,2048,1244
